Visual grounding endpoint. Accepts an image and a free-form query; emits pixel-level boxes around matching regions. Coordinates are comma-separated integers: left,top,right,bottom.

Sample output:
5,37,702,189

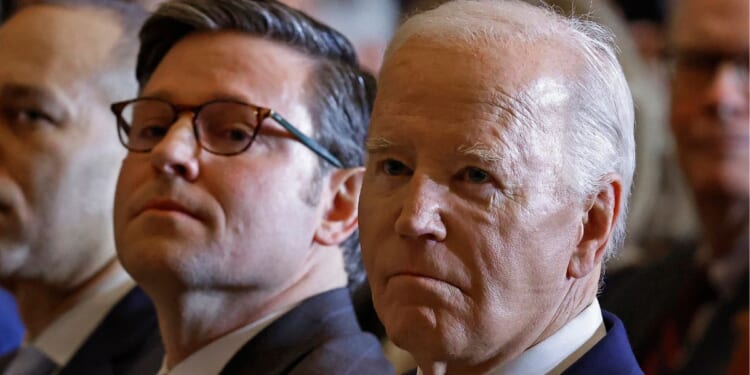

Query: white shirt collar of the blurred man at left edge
31,266,135,367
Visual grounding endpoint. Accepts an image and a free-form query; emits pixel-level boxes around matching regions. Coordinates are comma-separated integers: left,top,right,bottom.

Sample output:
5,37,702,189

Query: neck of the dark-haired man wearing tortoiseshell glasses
156,248,346,369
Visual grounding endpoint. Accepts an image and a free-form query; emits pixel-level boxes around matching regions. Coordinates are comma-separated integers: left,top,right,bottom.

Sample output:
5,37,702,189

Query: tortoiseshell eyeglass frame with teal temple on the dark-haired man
110,97,344,168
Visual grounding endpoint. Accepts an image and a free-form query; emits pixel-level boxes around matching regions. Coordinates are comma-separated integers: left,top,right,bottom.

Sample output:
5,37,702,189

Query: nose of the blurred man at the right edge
706,61,750,119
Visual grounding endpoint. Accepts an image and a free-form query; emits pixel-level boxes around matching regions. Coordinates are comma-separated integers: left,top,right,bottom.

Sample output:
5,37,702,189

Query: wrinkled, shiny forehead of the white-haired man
374,36,577,134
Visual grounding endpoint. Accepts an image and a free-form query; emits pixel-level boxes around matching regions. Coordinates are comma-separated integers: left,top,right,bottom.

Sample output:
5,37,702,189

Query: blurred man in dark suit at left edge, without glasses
0,0,156,374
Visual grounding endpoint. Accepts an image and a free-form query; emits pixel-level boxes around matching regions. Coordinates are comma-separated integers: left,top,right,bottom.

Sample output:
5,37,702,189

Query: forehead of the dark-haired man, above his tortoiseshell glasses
142,31,314,111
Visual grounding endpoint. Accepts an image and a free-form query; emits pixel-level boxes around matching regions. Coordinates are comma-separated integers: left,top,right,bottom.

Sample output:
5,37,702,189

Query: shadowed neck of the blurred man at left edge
11,258,120,341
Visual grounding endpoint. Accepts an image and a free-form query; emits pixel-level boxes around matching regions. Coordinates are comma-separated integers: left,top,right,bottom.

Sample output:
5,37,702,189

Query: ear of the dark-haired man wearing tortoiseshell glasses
314,167,365,246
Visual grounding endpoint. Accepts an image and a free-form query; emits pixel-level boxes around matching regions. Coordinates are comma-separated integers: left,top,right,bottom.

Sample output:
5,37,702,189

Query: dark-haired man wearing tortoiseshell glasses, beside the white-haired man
112,0,392,374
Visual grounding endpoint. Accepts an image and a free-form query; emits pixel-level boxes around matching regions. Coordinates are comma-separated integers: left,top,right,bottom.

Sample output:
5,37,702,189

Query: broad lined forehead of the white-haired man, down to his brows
372,38,571,156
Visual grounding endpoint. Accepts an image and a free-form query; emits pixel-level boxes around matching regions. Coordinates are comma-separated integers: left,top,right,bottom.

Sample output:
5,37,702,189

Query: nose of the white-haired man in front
395,173,447,241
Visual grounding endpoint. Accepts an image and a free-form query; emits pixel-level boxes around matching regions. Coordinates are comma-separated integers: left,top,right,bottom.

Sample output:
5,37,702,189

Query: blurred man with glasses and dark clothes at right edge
603,0,750,374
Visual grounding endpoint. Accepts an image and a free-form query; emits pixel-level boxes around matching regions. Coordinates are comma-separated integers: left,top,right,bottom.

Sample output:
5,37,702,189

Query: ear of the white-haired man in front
568,173,622,278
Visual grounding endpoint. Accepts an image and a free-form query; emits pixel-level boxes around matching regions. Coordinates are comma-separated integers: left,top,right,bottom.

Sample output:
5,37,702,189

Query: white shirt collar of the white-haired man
417,299,607,375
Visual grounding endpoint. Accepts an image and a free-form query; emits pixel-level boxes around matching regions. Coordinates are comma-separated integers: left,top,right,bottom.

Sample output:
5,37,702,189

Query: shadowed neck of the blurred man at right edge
696,195,749,258
